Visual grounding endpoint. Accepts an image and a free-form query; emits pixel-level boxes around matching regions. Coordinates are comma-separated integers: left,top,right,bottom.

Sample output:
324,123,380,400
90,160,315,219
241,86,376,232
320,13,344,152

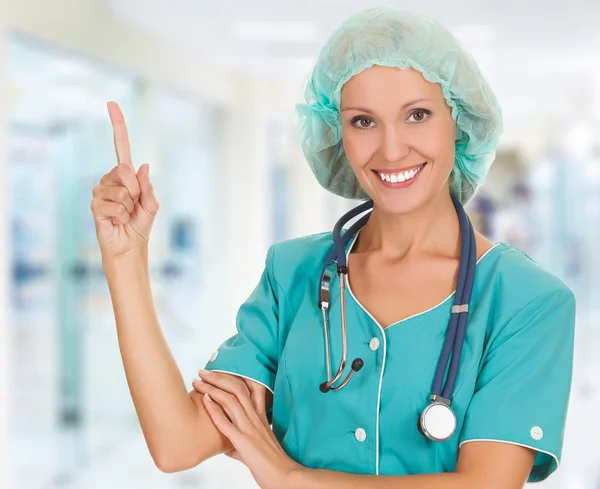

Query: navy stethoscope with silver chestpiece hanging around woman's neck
318,196,477,441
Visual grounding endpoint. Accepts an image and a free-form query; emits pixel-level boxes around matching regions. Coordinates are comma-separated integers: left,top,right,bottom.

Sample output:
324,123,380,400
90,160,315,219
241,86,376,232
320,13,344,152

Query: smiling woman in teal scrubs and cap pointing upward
92,4,575,489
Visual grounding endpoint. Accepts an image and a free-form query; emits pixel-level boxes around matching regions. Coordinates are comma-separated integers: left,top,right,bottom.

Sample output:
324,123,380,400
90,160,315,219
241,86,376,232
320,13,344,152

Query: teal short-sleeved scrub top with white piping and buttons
206,232,575,482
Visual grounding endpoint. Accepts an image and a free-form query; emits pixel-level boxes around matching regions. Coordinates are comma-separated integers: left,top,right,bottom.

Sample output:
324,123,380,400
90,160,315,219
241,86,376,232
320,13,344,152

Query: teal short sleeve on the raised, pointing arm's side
206,246,279,392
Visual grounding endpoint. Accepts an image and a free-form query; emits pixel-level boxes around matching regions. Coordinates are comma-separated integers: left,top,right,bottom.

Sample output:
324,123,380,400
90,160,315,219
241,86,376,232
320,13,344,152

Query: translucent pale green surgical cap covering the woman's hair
296,7,503,205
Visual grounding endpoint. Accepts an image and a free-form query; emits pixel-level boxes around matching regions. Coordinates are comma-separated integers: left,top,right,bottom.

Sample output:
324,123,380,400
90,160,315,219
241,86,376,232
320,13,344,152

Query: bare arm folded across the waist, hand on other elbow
192,371,535,489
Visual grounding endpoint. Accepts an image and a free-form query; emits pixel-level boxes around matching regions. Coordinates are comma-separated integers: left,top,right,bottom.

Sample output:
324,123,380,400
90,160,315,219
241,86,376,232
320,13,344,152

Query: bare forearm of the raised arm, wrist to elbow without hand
103,247,232,472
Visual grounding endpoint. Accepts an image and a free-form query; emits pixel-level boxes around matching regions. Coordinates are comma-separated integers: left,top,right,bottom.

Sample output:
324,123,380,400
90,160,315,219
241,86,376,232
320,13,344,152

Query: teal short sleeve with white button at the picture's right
460,287,575,482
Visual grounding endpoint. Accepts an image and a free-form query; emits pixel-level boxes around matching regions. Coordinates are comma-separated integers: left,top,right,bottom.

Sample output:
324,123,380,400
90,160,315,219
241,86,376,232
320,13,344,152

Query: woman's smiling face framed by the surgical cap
340,65,456,214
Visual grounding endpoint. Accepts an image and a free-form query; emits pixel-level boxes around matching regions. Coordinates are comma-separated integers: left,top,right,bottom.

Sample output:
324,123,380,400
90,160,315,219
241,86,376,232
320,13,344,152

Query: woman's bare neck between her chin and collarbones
355,191,460,260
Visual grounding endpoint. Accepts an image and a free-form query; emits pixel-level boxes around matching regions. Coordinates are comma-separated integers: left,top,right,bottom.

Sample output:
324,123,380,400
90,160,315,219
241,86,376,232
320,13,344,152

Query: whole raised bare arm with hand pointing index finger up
90,102,231,472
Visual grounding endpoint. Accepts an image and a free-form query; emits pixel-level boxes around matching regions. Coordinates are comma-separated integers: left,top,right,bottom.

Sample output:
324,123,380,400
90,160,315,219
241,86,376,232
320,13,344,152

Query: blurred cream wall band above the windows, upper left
0,0,231,102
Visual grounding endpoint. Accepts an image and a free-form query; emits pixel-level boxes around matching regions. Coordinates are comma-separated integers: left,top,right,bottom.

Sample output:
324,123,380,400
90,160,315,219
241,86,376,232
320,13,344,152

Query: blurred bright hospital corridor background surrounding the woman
0,0,600,489
